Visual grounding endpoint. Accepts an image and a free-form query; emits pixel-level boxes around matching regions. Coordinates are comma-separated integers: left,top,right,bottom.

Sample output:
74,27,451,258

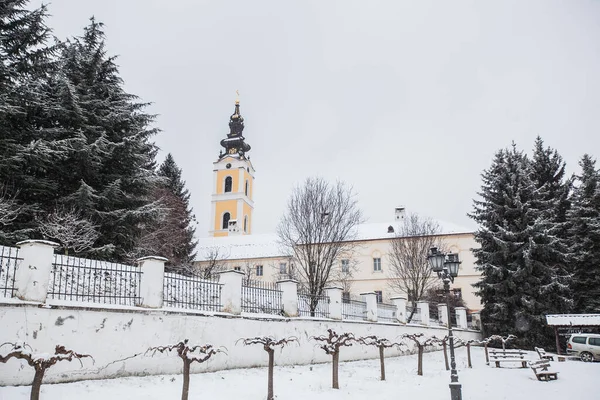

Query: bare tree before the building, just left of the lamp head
388,214,442,322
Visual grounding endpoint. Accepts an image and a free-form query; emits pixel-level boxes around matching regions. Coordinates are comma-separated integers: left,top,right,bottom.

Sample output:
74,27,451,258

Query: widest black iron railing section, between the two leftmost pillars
48,254,142,306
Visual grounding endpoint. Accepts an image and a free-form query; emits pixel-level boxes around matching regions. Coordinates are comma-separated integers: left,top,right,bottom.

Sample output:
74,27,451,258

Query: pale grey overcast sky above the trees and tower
32,0,600,237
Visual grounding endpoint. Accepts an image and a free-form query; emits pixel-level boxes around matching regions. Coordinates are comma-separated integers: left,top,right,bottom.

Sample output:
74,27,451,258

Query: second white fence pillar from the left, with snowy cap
135,256,168,308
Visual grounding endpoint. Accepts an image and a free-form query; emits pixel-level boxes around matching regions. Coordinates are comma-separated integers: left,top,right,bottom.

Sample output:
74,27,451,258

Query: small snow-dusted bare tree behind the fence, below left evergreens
38,207,100,255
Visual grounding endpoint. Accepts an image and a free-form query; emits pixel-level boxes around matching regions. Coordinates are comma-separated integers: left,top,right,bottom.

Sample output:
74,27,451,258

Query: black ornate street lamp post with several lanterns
427,247,462,400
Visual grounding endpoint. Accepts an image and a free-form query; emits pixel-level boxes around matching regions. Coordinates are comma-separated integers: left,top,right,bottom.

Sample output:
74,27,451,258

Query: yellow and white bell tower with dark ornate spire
209,99,254,236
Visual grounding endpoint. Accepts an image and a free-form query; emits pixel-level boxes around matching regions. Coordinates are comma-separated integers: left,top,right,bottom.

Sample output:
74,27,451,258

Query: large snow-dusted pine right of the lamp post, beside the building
470,144,571,347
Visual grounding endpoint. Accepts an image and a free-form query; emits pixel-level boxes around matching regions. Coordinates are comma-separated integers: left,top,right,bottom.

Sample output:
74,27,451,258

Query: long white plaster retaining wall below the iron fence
0,304,480,385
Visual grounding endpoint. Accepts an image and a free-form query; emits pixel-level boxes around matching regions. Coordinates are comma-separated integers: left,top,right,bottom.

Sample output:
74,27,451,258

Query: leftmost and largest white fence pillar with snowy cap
15,240,58,303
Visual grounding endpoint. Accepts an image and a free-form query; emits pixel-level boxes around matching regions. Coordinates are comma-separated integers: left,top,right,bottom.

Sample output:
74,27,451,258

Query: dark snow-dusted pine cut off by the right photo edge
567,154,600,313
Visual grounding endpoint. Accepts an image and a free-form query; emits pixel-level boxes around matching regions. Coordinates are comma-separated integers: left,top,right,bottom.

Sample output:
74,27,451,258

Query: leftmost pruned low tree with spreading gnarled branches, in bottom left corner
0,342,94,400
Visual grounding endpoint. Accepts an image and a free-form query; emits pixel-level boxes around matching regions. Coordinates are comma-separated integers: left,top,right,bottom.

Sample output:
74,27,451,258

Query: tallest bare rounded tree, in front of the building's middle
277,178,363,312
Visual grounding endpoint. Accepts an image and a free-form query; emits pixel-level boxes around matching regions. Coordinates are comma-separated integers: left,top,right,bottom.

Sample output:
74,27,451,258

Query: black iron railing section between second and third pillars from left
163,272,223,311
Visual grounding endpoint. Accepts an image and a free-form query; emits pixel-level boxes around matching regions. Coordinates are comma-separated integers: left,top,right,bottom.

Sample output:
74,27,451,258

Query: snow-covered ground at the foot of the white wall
0,348,600,400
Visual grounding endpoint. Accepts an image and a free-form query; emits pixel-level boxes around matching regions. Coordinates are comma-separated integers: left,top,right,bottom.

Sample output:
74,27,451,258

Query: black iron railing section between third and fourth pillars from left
242,281,284,315
